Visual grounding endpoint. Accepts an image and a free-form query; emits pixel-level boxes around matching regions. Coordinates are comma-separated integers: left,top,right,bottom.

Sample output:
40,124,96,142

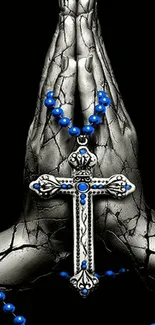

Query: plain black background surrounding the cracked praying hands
0,0,155,325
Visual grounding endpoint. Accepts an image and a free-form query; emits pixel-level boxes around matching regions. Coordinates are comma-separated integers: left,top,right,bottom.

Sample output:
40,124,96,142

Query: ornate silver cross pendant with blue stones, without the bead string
29,137,135,297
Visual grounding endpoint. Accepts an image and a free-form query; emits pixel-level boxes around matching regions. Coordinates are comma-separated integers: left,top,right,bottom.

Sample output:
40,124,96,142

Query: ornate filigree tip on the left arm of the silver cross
29,174,61,199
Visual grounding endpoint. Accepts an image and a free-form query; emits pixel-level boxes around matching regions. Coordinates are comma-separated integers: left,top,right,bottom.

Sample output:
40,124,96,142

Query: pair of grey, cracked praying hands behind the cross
0,0,155,289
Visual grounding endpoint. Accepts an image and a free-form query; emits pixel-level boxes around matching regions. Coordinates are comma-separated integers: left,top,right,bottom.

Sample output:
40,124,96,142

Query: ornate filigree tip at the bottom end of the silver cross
70,270,99,296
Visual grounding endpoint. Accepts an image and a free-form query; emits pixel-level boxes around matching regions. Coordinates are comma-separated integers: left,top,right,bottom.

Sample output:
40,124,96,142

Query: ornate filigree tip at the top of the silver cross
68,146,97,171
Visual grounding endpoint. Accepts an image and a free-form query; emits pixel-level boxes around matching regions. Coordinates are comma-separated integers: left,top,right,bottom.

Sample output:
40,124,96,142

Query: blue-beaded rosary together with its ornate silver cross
0,90,155,325
